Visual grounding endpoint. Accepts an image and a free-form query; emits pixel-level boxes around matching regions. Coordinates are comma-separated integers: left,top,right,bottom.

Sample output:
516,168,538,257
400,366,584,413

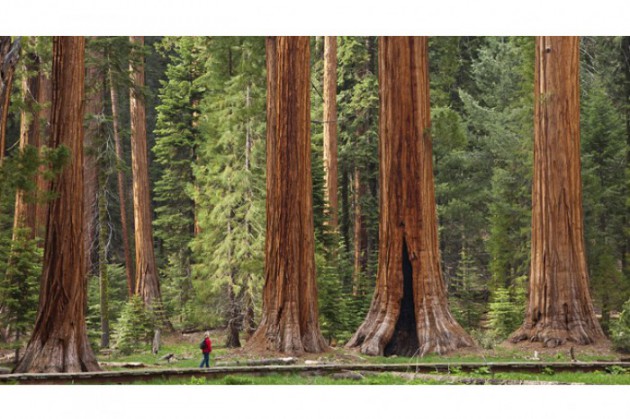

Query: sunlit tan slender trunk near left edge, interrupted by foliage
13,54,40,240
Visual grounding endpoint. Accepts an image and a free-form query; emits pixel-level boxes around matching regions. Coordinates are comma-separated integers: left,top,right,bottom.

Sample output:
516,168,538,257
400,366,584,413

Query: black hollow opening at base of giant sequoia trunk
385,240,419,356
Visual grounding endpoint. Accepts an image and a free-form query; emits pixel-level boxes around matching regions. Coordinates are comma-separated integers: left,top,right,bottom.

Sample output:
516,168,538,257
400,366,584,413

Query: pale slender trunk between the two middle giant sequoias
324,36,339,230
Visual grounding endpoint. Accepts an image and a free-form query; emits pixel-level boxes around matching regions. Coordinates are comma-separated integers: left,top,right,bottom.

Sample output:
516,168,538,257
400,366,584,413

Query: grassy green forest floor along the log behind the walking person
0,330,630,384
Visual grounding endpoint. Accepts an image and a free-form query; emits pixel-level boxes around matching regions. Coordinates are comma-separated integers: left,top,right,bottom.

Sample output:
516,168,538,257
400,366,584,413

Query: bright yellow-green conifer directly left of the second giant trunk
192,37,266,338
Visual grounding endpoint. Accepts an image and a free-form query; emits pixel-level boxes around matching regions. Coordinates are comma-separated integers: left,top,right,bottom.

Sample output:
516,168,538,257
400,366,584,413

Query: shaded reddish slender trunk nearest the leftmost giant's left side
35,69,52,240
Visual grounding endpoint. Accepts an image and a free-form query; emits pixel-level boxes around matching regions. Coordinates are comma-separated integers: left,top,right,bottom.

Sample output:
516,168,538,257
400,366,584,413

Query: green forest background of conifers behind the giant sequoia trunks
0,37,630,356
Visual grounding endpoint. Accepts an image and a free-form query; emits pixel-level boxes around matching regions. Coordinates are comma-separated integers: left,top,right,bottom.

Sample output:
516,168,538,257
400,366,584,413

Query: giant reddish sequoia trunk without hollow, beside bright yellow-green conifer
247,37,326,353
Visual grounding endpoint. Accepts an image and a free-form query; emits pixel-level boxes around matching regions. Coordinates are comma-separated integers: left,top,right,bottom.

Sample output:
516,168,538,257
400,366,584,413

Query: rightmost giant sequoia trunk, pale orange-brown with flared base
511,37,604,347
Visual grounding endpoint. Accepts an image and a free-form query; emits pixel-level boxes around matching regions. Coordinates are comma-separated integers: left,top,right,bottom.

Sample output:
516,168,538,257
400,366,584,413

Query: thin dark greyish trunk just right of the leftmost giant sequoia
98,167,109,348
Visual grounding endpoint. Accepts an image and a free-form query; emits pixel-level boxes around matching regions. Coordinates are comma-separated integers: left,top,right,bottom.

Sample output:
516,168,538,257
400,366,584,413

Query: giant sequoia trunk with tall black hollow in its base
348,37,473,356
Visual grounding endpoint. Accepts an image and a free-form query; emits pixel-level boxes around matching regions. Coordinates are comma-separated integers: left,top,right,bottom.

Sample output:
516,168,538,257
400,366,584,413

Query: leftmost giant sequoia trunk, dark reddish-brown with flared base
15,37,99,372
